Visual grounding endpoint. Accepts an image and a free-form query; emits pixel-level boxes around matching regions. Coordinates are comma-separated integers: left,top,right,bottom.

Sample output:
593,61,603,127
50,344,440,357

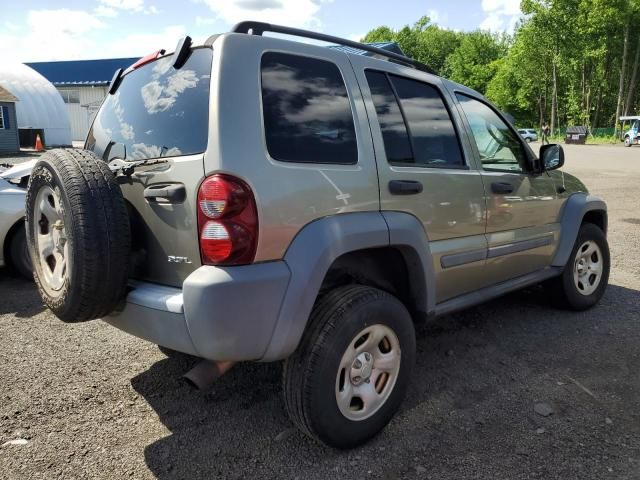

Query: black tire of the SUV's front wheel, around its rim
545,223,611,311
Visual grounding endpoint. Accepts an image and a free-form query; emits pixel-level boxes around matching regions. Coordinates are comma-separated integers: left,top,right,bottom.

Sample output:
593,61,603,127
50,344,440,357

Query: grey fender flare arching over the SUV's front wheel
551,192,607,267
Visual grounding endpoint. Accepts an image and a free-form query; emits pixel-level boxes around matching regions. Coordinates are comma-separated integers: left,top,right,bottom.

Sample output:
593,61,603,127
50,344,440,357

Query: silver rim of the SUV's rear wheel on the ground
335,324,401,421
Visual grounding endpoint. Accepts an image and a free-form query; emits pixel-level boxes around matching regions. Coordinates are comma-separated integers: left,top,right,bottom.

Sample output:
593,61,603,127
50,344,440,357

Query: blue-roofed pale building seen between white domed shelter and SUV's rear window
27,58,138,141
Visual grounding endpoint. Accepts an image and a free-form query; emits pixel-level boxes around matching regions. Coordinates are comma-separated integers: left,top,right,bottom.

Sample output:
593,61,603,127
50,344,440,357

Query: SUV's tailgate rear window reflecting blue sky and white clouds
86,48,212,161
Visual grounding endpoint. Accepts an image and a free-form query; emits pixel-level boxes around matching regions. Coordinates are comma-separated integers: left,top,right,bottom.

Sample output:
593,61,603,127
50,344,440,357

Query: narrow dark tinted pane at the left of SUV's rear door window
365,70,413,163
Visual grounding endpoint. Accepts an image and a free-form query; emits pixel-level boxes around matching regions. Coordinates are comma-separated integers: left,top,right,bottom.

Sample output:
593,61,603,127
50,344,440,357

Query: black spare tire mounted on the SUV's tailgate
26,149,131,322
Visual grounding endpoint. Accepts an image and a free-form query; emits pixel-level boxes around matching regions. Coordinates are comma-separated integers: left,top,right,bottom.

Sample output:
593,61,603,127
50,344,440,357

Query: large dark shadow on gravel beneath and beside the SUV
132,286,640,479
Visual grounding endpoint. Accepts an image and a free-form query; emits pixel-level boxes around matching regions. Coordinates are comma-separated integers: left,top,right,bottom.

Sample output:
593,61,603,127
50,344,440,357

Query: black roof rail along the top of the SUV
231,21,435,74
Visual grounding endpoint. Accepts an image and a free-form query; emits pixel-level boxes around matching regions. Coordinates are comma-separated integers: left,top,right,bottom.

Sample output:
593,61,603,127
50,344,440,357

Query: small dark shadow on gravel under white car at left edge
0,268,45,318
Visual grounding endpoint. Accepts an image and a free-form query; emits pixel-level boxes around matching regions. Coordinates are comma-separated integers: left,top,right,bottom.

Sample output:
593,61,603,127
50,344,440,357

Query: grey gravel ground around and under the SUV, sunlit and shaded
0,146,640,480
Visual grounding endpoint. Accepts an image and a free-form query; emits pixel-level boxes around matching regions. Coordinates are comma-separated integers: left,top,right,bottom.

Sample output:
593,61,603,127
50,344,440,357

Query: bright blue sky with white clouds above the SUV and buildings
0,0,521,62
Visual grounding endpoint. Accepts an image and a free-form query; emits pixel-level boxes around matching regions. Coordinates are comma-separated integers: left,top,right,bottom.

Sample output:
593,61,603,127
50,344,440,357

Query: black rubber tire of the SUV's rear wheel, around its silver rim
283,285,416,448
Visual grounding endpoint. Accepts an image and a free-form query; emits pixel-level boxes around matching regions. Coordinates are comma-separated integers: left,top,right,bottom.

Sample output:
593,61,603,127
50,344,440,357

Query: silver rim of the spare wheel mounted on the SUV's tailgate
33,186,70,295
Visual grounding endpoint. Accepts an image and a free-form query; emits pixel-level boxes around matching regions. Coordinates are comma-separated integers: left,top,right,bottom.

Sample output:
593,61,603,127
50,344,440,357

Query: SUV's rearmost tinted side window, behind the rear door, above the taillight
261,52,358,164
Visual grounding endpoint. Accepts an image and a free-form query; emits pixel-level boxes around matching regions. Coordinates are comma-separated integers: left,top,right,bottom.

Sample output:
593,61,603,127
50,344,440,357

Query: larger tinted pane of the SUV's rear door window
389,75,464,167
